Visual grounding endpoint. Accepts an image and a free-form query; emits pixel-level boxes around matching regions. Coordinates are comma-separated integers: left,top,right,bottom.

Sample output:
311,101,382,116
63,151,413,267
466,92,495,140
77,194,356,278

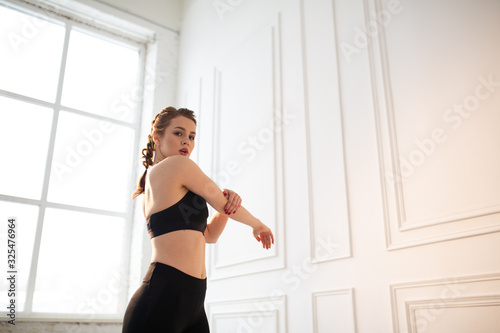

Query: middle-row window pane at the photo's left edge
0,96,53,199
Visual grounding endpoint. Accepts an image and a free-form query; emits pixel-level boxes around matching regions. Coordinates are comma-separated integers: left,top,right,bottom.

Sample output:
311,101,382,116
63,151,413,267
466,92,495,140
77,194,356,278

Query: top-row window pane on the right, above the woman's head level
62,30,140,122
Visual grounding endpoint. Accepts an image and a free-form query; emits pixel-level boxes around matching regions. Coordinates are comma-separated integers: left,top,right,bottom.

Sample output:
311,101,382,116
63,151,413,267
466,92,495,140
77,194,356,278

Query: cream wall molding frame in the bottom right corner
390,274,500,333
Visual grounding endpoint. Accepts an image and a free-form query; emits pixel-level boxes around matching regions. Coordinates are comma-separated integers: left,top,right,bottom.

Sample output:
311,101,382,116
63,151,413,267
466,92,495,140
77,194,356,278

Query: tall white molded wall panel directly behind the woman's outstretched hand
209,15,285,280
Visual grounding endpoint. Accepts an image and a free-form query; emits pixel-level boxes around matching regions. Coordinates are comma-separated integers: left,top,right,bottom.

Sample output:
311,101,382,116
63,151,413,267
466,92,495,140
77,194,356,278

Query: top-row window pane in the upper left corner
0,6,65,102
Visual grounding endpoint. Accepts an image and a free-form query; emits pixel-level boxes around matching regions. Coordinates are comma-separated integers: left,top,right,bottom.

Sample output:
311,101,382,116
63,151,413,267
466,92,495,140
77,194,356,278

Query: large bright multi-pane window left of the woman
0,2,145,318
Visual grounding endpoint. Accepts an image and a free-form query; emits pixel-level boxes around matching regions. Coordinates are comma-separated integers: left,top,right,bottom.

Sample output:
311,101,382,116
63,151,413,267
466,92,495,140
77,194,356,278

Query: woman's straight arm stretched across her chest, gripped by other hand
162,155,274,248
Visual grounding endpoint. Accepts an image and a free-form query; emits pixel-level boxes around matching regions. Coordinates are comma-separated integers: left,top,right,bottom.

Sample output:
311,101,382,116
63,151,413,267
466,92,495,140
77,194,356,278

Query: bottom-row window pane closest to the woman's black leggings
33,208,125,314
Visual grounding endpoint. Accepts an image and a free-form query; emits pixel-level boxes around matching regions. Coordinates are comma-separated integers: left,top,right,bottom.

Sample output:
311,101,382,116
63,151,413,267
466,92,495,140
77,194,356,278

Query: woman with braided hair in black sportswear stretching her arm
123,107,274,333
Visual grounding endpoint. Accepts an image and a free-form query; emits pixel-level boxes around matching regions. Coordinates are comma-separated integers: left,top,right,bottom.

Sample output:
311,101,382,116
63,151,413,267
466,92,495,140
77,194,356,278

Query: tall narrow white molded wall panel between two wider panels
301,0,351,263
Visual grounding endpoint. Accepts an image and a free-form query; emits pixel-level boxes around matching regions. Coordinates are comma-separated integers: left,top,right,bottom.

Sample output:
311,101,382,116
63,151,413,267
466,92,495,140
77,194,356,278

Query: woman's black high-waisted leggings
122,262,210,333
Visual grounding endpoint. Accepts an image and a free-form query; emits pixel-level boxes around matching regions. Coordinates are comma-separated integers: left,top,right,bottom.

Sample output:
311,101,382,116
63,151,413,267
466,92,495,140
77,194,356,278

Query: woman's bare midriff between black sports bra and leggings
151,230,207,279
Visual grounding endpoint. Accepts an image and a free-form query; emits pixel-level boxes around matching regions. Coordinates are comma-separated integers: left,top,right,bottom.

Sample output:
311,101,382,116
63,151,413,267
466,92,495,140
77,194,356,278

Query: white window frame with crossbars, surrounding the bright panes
0,0,178,322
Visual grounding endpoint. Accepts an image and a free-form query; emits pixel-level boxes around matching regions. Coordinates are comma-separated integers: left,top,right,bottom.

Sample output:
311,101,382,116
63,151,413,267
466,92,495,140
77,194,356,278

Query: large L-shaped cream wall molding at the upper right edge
363,0,500,250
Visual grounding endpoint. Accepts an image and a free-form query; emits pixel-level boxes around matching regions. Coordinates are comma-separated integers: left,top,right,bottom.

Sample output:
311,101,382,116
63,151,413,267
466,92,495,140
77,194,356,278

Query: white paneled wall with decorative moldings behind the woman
177,0,500,333
